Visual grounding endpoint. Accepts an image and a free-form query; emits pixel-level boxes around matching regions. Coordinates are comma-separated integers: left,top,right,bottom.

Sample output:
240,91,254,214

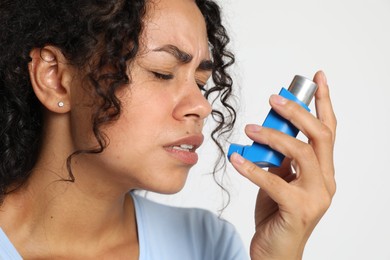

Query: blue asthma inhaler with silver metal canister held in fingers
228,75,318,167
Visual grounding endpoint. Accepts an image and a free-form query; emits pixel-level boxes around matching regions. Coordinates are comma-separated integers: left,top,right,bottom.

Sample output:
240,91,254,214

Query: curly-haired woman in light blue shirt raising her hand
0,0,336,259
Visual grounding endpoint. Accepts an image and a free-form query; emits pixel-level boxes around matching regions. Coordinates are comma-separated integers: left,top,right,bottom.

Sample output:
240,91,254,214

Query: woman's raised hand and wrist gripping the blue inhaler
230,71,336,260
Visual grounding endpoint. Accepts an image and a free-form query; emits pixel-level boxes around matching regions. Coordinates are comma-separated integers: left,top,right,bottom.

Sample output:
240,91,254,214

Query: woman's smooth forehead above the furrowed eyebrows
142,0,209,56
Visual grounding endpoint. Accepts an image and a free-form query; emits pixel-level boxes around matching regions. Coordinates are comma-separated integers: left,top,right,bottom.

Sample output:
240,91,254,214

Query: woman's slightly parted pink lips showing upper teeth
164,135,204,165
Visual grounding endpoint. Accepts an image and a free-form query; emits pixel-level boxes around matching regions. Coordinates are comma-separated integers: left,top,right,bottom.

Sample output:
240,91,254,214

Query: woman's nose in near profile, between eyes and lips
173,81,212,120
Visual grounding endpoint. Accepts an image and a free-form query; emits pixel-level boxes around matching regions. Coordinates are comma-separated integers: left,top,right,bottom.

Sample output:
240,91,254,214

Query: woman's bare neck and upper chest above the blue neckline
0,113,138,258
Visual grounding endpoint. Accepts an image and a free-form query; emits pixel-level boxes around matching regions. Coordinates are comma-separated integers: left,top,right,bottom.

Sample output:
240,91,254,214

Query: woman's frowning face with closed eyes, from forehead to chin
69,0,212,193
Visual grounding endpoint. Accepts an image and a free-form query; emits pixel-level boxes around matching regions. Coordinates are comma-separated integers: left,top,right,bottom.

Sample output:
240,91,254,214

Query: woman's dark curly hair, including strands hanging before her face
0,0,236,204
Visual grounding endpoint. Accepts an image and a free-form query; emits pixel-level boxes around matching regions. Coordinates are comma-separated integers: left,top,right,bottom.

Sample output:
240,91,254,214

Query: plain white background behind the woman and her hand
150,0,390,260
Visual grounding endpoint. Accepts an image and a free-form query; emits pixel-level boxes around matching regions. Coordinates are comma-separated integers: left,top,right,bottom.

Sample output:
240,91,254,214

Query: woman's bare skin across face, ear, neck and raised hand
0,0,336,259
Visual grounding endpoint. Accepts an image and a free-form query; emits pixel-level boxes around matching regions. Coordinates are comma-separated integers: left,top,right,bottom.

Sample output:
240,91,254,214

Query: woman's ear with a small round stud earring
28,46,73,113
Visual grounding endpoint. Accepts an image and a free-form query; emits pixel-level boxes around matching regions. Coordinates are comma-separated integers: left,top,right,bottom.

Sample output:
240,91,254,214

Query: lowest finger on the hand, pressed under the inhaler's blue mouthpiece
230,153,290,205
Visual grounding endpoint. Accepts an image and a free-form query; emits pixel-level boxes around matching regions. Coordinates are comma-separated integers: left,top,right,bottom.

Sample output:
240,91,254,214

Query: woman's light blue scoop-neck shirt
0,193,249,260
